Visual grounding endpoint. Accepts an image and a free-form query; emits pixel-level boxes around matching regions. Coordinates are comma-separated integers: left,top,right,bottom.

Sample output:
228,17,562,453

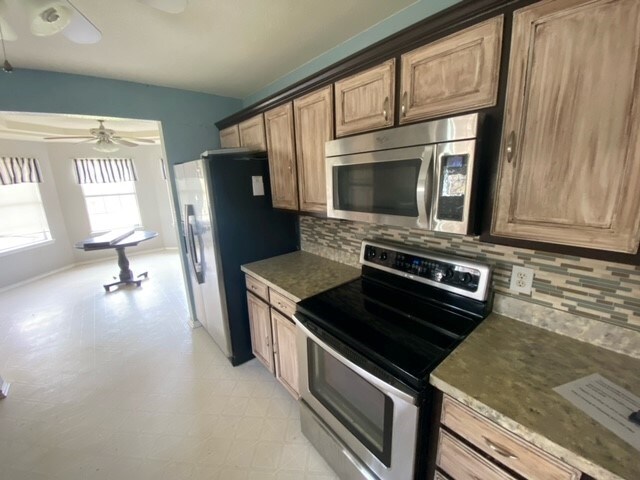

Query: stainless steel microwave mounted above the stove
325,113,479,234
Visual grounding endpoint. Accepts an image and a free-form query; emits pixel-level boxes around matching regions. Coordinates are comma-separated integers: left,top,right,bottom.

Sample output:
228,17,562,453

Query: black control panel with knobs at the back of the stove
363,245,482,292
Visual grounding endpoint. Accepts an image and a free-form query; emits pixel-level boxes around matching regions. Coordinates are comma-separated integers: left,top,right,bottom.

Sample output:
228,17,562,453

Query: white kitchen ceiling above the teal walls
0,0,416,98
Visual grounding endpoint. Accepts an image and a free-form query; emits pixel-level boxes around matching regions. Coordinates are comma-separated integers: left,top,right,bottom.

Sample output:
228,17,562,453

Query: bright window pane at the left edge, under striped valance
0,183,51,252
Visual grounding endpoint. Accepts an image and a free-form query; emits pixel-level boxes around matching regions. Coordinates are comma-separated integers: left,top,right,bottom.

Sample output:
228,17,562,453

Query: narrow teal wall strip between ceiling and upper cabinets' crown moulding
242,0,462,108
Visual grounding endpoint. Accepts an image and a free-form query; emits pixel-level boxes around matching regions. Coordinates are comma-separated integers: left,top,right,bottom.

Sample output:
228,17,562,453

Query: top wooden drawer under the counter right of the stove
441,395,581,480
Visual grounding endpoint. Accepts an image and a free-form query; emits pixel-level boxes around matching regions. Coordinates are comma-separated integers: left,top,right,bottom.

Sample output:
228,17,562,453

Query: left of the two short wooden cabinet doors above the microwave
334,59,396,137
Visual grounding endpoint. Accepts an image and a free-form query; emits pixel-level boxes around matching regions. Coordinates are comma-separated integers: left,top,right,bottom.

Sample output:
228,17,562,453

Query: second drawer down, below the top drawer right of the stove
436,430,515,480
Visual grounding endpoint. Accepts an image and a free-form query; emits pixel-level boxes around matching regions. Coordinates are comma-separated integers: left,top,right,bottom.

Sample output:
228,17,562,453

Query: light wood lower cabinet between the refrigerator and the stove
245,275,300,400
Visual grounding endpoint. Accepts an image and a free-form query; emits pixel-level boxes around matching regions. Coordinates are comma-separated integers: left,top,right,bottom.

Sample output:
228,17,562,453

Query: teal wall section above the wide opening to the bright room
0,68,242,167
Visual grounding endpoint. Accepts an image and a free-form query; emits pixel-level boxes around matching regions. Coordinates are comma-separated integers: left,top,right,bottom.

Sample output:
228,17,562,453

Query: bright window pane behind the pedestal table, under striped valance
81,182,140,233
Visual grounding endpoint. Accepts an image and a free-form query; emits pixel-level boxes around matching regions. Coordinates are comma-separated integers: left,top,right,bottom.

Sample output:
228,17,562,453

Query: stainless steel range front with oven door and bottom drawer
295,313,419,480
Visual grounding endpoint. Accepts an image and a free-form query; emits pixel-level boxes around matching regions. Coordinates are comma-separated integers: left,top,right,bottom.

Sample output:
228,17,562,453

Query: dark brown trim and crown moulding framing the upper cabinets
216,0,640,265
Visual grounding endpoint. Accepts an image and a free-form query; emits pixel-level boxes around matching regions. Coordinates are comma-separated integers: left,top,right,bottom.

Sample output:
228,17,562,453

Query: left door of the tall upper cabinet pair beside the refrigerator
264,102,298,210
